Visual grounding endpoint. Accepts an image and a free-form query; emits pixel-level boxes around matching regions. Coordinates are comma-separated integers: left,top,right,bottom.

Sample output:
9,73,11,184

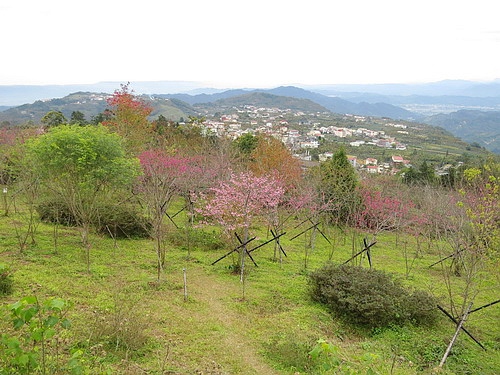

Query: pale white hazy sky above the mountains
0,0,500,88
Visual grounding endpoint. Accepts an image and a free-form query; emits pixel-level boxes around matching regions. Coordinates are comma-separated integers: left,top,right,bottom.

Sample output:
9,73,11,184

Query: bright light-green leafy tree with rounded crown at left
26,125,139,270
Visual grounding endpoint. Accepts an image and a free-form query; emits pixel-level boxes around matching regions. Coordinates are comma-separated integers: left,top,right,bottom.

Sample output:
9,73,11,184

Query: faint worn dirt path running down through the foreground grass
189,270,279,375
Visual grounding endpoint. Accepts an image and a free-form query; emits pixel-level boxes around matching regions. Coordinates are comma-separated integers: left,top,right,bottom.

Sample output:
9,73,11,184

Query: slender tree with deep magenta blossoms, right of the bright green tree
138,150,202,280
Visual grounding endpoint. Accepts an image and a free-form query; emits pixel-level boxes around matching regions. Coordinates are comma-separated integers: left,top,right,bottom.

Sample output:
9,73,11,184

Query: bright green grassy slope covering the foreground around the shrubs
0,207,500,375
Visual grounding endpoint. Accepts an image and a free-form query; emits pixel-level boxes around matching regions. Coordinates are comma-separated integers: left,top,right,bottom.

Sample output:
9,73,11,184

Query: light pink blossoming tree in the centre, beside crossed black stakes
196,172,284,281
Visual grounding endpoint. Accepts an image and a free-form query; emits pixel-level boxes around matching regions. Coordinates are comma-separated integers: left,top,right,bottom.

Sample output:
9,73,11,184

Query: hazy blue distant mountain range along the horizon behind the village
0,80,500,153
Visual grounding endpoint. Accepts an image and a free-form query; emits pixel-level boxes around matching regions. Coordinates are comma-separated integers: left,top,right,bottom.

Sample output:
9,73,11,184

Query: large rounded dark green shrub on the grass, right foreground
310,264,437,327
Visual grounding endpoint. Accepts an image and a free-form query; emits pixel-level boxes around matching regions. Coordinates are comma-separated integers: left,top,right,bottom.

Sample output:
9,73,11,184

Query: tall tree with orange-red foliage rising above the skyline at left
103,83,153,153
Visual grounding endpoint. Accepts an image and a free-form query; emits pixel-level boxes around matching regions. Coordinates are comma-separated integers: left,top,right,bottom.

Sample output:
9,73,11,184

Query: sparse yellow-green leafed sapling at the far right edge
439,164,500,316
